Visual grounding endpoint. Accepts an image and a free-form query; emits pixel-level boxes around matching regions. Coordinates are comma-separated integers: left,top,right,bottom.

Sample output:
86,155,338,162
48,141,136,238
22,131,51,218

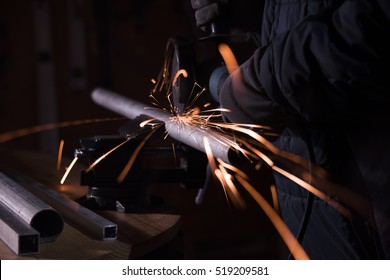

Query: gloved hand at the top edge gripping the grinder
191,0,228,30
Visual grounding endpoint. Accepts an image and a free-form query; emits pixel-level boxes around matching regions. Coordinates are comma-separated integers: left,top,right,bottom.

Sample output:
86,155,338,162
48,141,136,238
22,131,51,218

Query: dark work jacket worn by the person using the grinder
220,0,390,259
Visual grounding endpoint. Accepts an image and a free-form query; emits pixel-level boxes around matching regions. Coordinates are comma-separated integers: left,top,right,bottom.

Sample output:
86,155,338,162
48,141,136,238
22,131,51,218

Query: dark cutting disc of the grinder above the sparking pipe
166,37,196,114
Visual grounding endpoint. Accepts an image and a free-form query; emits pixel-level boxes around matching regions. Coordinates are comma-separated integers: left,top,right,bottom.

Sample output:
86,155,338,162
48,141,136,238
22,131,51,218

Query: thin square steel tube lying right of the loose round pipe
10,173,118,240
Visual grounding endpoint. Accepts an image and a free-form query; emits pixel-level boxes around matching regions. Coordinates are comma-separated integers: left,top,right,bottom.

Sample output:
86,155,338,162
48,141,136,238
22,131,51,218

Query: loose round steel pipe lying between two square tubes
0,172,64,243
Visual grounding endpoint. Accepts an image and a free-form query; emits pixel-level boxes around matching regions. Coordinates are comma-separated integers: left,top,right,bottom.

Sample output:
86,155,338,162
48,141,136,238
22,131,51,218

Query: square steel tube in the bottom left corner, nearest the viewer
0,202,39,255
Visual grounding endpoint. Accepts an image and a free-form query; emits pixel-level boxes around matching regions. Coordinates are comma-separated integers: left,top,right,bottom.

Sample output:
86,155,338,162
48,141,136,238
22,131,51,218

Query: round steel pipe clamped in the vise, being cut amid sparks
92,88,234,162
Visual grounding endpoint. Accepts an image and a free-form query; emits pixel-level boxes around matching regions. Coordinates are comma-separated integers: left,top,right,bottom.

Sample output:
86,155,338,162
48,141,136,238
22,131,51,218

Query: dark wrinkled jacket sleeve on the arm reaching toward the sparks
221,0,390,125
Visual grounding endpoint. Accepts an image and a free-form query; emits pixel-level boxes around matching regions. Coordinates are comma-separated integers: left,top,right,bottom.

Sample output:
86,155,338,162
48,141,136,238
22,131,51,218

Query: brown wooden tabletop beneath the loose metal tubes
0,150,180,259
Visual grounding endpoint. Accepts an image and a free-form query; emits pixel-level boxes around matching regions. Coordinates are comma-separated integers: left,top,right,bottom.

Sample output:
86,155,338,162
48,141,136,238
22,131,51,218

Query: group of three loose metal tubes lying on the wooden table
0,172,117,255
